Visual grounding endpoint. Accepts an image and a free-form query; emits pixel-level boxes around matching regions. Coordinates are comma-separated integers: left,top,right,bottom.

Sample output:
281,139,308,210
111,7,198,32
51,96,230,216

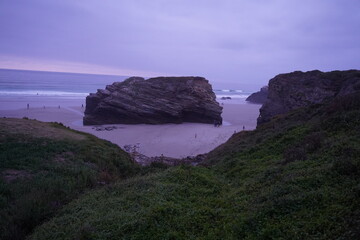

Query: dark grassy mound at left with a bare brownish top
0,118,138,239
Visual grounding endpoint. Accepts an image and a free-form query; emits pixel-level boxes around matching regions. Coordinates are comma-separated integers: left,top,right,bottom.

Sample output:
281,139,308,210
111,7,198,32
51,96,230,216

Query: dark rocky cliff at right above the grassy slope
258,70,360,124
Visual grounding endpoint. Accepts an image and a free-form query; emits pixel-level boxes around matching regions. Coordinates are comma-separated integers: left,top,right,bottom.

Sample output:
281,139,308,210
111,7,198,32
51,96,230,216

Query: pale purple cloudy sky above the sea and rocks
0,0,360,90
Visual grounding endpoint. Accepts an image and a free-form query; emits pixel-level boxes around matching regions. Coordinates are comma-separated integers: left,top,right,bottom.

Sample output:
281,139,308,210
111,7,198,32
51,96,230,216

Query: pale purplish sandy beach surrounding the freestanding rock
0,99,261,158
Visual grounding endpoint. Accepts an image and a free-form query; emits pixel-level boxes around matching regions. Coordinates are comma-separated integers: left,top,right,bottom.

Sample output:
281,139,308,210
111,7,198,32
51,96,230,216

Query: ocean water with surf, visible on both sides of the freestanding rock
0,69,250,109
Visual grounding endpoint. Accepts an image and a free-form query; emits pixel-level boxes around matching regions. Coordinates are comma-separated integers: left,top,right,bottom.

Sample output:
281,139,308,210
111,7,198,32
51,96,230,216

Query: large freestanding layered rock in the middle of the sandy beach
84,77,222,125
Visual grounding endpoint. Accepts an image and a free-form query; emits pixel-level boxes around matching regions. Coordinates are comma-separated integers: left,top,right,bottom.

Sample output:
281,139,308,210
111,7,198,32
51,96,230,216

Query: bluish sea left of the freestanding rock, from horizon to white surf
0,69,127,98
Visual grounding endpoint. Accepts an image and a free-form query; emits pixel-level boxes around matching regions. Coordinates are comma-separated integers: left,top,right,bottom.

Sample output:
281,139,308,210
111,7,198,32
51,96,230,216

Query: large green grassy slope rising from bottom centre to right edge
31,91,360,239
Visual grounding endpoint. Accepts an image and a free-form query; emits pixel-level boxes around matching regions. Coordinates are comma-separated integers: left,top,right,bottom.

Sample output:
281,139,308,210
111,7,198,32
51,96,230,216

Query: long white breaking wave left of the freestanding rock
0,90,89,97
